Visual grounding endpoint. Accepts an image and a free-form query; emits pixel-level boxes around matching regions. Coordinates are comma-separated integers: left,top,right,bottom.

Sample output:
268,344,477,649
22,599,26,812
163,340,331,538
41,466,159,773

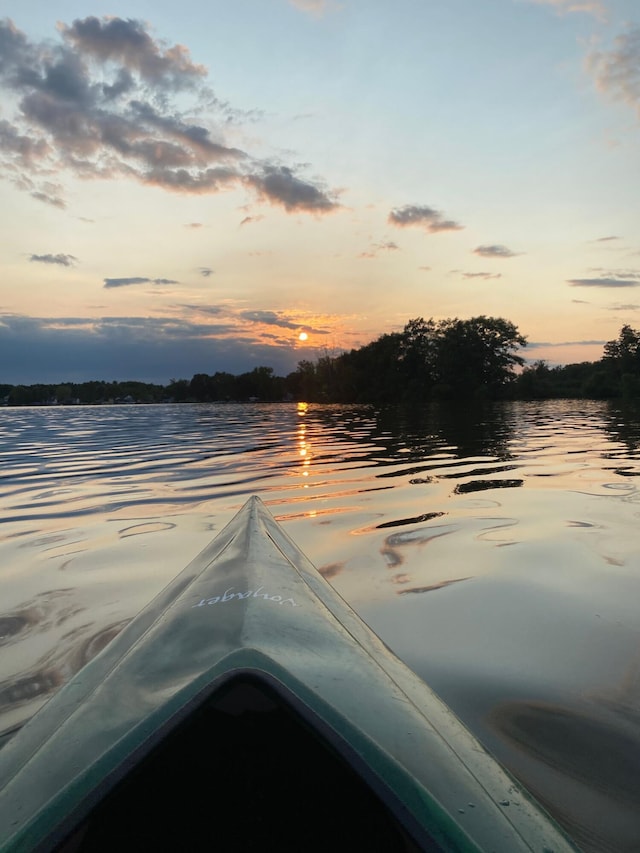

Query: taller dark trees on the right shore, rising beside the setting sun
295,316,640,404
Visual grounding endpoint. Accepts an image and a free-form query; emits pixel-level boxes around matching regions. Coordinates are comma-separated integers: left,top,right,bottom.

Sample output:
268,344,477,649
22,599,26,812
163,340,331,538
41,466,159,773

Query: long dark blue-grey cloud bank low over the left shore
0,315,314,384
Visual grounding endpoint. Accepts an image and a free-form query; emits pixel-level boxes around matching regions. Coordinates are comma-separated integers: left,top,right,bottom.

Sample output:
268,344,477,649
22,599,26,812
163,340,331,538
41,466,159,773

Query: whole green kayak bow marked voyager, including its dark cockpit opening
0,497,576,853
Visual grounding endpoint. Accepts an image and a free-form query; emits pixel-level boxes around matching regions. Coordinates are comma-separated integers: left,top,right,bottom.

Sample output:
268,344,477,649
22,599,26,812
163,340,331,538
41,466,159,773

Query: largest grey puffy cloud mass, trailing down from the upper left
0,16,339,213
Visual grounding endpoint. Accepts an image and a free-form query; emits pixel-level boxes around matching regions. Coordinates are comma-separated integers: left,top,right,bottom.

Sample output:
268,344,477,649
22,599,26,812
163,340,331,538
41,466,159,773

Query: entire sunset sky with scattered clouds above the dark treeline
0,0,640,384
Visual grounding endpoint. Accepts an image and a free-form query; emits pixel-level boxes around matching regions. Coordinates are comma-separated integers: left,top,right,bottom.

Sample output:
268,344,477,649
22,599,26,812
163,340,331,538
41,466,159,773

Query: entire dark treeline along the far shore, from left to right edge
0,316,640,405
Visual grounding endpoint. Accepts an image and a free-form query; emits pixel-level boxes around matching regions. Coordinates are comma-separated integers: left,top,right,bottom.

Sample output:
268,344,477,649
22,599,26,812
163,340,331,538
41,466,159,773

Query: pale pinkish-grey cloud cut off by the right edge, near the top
587,26,640,114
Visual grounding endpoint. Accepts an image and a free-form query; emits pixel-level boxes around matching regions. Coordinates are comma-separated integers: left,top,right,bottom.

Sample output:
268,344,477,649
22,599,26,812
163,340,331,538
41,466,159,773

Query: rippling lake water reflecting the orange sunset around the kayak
0,401,640,853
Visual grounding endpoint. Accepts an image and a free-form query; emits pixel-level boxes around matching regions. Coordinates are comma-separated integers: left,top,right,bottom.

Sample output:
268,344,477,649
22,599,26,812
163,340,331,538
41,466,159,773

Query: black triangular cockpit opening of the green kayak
54,675,440,853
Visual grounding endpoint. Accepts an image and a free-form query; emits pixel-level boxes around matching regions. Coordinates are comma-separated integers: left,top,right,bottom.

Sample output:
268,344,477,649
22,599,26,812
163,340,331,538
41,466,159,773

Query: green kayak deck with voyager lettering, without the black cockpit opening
0,497,575,853
